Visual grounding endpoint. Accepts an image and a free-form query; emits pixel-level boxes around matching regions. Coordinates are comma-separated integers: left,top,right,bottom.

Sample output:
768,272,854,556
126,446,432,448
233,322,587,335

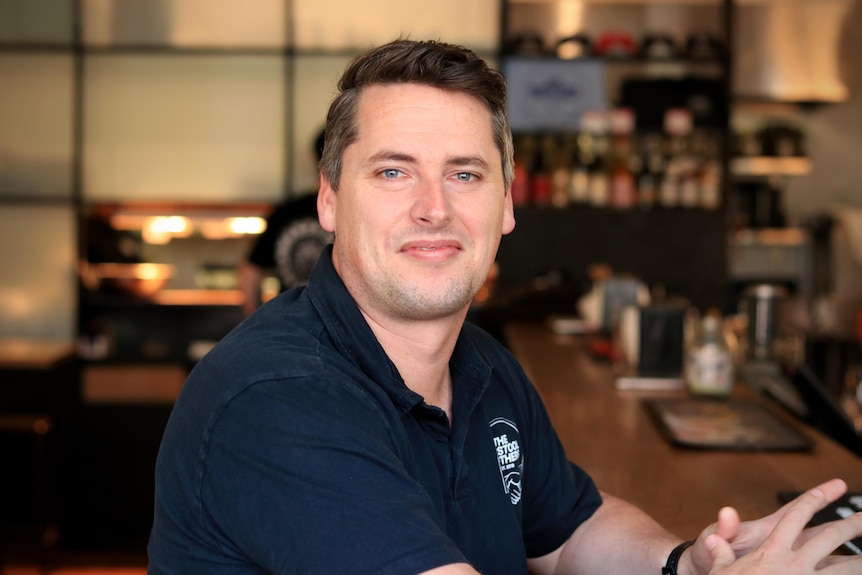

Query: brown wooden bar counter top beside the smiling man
504,322,862,538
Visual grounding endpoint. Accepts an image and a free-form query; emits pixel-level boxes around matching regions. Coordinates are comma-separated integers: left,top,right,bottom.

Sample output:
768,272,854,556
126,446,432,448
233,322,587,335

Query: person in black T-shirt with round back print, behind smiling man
237,130,332,315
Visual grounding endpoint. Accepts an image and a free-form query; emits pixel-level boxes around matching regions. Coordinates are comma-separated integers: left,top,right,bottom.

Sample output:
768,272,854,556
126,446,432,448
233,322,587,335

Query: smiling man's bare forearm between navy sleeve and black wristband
529,493,682,575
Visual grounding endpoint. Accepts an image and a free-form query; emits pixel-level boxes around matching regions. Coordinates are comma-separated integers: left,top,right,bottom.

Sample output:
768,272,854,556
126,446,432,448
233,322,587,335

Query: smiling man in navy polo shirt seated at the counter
149,40,862,575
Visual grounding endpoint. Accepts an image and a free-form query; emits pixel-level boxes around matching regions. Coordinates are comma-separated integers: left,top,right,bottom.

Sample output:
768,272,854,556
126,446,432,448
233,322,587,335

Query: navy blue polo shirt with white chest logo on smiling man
149,247,601,575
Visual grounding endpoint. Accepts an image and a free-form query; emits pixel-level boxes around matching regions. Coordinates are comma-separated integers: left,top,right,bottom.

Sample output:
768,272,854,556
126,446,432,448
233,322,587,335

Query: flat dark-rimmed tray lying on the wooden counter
644,397,813,451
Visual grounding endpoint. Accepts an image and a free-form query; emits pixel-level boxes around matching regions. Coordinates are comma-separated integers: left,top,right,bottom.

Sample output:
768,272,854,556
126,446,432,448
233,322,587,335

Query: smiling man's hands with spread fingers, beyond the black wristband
690,479,862,575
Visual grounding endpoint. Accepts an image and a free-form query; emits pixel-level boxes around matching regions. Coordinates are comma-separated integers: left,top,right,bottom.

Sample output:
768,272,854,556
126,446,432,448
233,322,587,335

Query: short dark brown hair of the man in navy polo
320,39,514,191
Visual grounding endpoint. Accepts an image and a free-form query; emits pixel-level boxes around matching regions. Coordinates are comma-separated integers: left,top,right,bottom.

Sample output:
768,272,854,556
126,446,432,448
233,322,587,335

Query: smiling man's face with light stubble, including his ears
318,84,515,320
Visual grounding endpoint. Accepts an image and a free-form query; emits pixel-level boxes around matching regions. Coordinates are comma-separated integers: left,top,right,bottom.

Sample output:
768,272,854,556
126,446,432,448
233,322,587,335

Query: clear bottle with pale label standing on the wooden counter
685,310,733,396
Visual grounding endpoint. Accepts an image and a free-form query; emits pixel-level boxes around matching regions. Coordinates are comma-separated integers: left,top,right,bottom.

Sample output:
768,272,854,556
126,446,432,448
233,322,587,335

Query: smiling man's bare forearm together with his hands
530,480,862,575
